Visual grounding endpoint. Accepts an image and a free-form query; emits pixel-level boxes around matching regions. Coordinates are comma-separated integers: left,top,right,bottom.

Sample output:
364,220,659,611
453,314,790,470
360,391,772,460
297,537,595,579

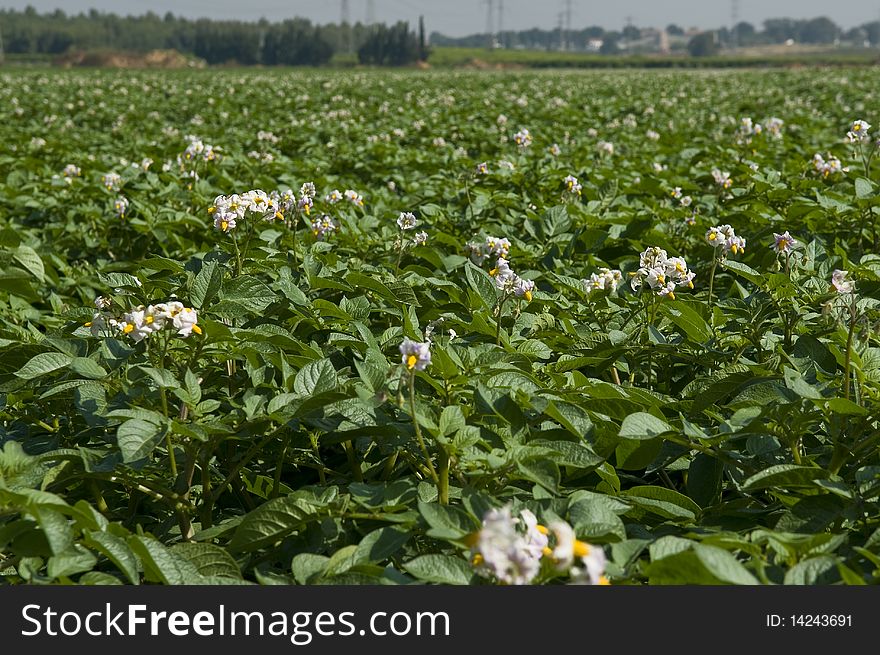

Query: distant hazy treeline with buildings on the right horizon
431,16,880,54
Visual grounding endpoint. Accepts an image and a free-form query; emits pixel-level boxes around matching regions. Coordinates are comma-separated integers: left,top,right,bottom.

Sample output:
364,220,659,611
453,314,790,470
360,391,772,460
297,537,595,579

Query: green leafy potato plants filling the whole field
0,68,880,584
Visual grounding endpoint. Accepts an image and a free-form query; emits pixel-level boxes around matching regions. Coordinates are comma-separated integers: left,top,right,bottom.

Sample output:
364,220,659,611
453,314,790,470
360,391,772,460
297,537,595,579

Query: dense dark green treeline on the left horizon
0,7,428,66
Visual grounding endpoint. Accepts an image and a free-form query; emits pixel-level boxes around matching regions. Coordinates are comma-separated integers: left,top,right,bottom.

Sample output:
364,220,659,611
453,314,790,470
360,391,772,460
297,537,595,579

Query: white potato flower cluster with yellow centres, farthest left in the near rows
86,297,202,342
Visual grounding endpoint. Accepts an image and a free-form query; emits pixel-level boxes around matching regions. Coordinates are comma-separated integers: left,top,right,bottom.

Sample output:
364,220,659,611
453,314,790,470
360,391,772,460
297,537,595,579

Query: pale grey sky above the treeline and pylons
0,0,880,36
